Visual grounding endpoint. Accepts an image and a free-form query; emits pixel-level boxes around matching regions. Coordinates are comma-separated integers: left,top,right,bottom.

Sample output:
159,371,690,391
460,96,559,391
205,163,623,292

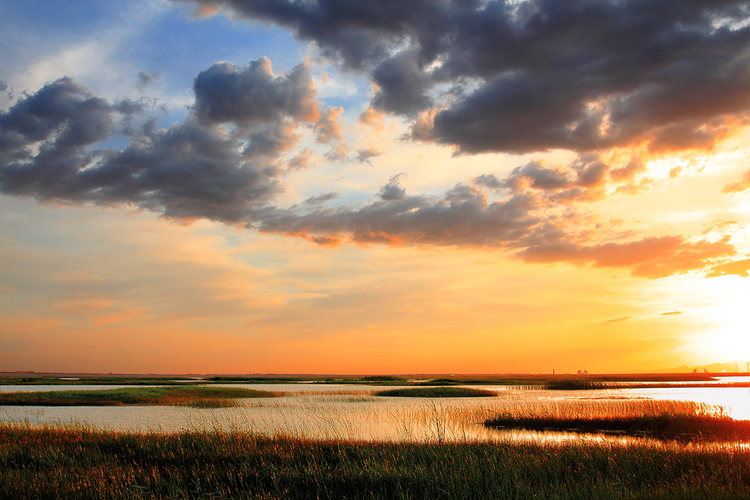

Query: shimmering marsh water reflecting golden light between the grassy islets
0,379,750,443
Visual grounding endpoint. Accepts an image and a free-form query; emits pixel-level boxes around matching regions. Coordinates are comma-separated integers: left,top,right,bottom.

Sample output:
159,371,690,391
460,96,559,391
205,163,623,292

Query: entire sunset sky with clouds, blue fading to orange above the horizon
0,0,750,374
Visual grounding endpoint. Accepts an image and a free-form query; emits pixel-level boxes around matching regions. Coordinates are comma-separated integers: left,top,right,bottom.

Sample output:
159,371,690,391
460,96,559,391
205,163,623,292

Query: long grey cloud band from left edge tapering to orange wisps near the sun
0,59,736,278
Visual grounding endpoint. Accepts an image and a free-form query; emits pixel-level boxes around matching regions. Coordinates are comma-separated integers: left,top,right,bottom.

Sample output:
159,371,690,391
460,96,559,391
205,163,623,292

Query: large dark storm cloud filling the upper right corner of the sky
178,0,750,153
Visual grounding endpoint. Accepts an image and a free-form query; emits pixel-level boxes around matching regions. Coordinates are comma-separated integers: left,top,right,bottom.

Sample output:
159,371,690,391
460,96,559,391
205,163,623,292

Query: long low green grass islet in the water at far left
0,385,278,408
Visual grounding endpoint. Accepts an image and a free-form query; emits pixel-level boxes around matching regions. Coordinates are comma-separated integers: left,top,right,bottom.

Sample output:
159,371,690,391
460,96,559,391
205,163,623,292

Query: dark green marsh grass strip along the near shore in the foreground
0,426,750,499
